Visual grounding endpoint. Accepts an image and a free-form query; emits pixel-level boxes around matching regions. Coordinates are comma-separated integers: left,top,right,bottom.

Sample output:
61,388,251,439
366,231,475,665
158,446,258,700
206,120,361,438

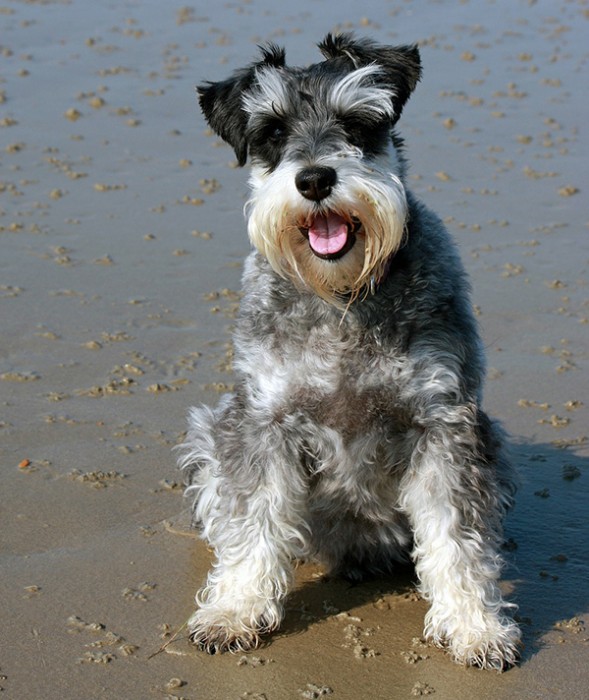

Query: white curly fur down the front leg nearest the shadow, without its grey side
400,430,520,670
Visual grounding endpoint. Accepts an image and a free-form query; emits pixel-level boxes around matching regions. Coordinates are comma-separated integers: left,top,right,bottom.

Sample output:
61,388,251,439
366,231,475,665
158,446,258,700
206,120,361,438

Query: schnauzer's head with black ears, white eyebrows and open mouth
198,35,421,304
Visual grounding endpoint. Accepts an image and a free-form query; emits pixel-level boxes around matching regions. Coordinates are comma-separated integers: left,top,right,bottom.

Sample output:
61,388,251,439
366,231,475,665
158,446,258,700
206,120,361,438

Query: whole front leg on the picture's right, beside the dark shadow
401,406,520,670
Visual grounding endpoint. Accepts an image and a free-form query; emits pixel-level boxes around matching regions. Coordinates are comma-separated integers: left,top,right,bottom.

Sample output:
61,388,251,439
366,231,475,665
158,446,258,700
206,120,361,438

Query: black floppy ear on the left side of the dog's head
196,44,285,165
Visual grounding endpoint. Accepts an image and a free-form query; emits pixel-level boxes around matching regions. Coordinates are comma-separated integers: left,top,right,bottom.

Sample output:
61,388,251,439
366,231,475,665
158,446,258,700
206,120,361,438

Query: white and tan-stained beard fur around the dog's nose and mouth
246,146,407,292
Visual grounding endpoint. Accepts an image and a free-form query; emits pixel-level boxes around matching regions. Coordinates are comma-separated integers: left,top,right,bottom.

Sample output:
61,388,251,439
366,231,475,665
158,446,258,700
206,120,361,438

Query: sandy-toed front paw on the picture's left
188,609,271,654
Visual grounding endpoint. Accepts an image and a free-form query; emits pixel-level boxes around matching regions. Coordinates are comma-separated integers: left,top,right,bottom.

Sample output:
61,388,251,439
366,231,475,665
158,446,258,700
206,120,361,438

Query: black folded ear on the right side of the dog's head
319,34,421,122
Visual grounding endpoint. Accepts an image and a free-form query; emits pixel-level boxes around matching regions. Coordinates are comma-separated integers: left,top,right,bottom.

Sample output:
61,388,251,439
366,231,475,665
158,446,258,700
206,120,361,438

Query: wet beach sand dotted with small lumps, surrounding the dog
0,0,589,700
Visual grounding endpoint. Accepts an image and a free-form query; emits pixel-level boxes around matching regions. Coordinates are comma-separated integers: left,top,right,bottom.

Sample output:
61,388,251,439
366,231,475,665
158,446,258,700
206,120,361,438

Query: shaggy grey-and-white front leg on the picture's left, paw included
189,400,308,653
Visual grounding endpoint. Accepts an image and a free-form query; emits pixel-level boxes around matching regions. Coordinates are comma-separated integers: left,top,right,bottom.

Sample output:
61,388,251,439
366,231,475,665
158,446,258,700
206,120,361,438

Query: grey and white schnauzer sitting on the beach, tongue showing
180,34,520,670
